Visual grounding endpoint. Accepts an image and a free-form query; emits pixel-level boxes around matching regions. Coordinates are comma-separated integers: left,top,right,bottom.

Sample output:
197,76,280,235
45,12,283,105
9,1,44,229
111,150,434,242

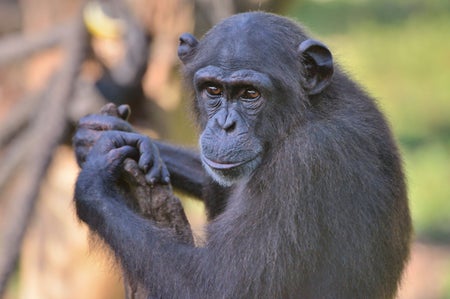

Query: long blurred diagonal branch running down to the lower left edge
0,15,87,297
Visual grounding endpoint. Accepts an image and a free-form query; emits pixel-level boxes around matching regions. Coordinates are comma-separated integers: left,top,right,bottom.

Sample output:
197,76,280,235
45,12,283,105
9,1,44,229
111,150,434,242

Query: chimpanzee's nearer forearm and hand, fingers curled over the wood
75,131,204,298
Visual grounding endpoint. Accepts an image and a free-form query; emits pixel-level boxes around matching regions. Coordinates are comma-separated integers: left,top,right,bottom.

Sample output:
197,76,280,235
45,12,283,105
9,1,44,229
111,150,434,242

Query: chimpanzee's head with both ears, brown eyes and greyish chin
178,12,333,185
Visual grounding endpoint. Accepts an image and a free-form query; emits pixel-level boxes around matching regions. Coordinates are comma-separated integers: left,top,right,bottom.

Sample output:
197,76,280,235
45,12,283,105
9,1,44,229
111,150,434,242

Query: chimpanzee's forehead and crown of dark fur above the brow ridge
196,13,304,69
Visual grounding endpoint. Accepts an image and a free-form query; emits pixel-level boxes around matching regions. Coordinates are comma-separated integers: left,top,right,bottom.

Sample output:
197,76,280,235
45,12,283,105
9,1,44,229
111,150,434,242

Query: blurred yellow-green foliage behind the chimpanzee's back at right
287,0,450,242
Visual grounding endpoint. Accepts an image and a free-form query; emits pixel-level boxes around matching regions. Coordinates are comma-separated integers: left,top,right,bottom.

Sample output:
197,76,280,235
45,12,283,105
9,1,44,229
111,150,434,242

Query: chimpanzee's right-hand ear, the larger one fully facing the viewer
298,39,333,95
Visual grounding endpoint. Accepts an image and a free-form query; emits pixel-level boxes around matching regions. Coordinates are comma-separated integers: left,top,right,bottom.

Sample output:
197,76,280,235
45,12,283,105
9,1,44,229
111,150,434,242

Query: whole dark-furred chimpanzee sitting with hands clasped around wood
74,12,411,299
